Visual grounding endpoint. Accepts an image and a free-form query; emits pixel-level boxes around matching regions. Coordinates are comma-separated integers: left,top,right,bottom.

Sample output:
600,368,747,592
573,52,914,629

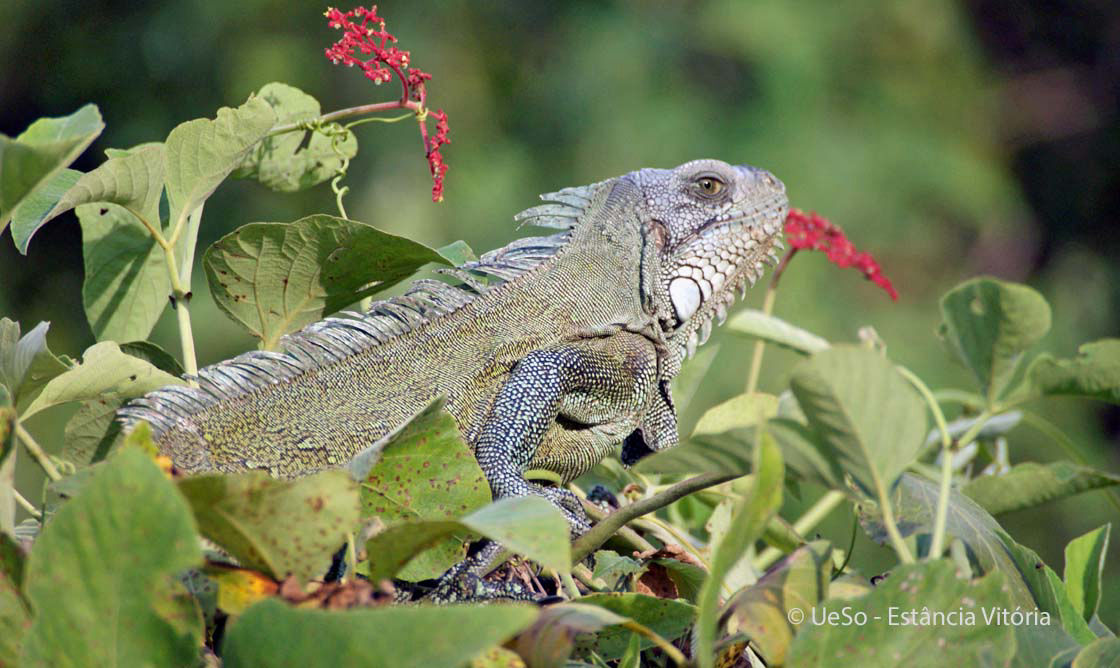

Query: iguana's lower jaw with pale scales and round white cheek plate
666,192,788,358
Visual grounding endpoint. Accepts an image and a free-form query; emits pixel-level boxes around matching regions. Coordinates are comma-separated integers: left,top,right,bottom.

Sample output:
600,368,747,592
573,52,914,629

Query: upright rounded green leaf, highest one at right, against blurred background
939,278,1051,403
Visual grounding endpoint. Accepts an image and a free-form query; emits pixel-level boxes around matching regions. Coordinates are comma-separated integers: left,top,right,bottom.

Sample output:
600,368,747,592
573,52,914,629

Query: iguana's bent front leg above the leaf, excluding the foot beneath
475,331,659,535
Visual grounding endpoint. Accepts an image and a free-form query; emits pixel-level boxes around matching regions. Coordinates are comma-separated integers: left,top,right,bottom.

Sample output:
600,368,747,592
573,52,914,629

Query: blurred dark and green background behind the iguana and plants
0,0,1120,627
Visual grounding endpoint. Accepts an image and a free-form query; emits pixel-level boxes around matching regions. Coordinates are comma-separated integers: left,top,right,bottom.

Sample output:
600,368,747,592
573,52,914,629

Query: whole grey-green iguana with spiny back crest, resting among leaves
120,160,787,600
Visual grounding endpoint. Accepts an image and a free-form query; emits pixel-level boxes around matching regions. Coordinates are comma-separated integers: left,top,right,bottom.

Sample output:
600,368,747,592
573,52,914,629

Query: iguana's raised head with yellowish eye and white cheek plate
629,160,788,355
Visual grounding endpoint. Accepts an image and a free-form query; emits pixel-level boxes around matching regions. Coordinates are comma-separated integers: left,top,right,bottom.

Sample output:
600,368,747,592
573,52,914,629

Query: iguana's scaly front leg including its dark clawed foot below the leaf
427,328,675,602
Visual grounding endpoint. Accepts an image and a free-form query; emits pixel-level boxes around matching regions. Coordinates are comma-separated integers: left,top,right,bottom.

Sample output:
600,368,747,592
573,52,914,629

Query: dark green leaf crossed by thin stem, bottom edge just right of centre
563,593,697,661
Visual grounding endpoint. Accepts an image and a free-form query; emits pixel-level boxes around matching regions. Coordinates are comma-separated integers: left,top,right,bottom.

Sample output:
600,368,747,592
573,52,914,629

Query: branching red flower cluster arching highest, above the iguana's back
325,4,451,202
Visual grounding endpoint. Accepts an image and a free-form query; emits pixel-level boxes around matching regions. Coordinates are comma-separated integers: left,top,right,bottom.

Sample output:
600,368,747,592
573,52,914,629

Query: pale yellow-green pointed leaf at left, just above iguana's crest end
22,341,184,418
